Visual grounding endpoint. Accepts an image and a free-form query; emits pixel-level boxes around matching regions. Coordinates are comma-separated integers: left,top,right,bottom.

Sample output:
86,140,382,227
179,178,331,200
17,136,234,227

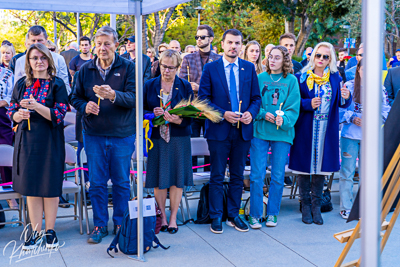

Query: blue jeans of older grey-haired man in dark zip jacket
83,133,135,227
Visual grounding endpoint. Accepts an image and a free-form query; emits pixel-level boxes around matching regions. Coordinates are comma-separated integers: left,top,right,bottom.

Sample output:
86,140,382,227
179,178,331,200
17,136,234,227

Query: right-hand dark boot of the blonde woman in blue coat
311,175,325,225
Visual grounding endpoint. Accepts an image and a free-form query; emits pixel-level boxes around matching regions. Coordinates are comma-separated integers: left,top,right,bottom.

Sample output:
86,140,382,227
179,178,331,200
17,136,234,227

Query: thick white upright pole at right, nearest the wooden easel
360,0,384,267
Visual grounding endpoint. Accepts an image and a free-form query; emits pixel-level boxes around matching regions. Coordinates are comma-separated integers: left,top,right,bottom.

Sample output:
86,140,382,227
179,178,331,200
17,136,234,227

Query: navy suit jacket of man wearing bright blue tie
199,58,261,141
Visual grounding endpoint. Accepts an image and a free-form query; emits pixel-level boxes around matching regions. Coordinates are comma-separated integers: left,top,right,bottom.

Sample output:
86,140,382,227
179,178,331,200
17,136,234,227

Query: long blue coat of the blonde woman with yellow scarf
289,72,352,173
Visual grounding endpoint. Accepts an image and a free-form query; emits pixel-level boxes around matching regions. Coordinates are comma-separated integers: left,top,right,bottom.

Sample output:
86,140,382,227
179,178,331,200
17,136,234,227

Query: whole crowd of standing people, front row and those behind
0,19,400,250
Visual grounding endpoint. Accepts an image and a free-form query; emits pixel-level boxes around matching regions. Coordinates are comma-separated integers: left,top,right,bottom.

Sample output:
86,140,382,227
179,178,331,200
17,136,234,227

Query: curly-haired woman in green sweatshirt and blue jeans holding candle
249,46,300,229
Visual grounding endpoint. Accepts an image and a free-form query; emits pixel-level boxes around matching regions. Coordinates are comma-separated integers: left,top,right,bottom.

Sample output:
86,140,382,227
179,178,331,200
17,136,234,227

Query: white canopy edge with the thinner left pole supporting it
0,0,189,261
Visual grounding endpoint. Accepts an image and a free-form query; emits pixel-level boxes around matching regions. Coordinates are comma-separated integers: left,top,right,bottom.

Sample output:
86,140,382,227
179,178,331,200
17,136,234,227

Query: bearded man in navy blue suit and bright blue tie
199,29,261,234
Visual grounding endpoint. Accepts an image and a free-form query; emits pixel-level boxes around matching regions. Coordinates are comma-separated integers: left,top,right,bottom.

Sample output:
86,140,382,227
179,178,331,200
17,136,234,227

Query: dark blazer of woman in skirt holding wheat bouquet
143,75,193,139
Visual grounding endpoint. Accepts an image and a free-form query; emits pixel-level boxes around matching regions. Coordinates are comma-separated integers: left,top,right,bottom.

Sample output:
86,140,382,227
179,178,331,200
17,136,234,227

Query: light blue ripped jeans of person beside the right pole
339,137,361,211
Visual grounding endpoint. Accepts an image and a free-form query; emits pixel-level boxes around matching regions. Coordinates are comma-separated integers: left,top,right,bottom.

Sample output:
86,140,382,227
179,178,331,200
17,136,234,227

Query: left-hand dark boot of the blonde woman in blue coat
297,175,313,224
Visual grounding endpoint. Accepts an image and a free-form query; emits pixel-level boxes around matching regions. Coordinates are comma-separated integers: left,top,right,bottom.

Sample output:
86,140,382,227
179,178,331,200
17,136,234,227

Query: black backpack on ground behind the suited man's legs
194,182,229,224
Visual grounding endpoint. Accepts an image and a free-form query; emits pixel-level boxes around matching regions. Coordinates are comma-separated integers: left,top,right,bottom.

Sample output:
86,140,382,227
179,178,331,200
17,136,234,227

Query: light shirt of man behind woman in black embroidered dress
14,51,71,95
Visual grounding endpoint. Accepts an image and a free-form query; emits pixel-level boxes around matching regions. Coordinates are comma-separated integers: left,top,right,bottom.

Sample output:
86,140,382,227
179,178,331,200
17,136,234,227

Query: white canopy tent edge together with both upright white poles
0,0,384,266
